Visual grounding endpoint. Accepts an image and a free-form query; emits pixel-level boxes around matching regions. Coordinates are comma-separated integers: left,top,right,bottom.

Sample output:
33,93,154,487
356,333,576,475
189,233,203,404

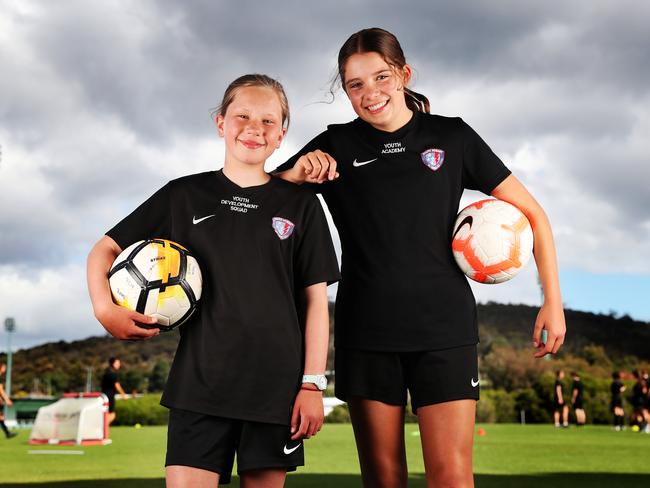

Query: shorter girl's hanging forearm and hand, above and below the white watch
291,283,329,440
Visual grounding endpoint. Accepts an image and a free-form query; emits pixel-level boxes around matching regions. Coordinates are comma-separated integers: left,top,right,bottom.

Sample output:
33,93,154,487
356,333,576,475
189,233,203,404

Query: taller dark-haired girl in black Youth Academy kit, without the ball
277,28,565,488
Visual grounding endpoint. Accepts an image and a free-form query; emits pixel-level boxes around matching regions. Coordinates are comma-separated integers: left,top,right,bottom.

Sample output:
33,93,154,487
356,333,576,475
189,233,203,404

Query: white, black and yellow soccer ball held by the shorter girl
108,239,203,331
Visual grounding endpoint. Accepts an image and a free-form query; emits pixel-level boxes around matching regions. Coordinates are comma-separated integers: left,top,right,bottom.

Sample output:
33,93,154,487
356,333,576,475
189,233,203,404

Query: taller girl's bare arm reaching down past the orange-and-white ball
492,175,566,358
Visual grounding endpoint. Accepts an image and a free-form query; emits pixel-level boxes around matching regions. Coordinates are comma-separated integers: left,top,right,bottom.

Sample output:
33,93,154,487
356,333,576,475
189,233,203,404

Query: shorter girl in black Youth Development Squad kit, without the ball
88,75,339,488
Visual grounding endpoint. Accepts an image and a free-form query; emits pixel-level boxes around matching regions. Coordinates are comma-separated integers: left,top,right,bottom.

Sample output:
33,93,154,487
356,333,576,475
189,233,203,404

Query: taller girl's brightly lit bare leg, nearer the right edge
417,400,476,488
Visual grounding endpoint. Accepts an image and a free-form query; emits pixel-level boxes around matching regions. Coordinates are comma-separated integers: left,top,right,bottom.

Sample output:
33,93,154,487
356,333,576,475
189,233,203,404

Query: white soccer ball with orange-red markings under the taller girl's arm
451,199,533,284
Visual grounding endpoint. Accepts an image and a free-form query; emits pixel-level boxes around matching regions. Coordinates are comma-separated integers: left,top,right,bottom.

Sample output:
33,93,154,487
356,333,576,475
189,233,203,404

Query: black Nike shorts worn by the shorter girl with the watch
165,408,305,484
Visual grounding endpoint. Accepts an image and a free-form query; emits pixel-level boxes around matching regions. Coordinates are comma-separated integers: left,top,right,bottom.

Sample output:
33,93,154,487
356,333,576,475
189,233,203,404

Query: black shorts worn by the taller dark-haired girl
334,344,479,413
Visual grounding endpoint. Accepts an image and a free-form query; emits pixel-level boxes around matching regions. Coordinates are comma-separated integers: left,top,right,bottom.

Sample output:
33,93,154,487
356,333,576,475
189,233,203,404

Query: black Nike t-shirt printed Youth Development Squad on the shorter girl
107,171,339,424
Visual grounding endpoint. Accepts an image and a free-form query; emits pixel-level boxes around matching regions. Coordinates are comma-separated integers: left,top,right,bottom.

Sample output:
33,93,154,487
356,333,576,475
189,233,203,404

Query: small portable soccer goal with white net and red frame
29,392,111,445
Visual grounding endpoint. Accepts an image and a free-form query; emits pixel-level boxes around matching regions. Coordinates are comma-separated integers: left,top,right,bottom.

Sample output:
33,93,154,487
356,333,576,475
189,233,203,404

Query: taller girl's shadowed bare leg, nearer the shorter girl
348,398,408,488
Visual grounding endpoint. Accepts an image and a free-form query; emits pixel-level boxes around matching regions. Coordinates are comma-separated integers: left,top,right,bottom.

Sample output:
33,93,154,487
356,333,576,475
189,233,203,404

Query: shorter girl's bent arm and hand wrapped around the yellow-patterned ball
87,236,160,340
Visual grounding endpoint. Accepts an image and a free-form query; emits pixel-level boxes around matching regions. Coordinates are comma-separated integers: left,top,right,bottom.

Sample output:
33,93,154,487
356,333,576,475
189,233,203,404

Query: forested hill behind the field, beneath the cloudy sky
0,303,650,394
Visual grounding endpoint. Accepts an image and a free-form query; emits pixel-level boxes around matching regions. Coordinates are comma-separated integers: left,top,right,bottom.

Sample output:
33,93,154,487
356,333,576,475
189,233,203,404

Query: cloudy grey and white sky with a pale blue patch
0,0,650,350
